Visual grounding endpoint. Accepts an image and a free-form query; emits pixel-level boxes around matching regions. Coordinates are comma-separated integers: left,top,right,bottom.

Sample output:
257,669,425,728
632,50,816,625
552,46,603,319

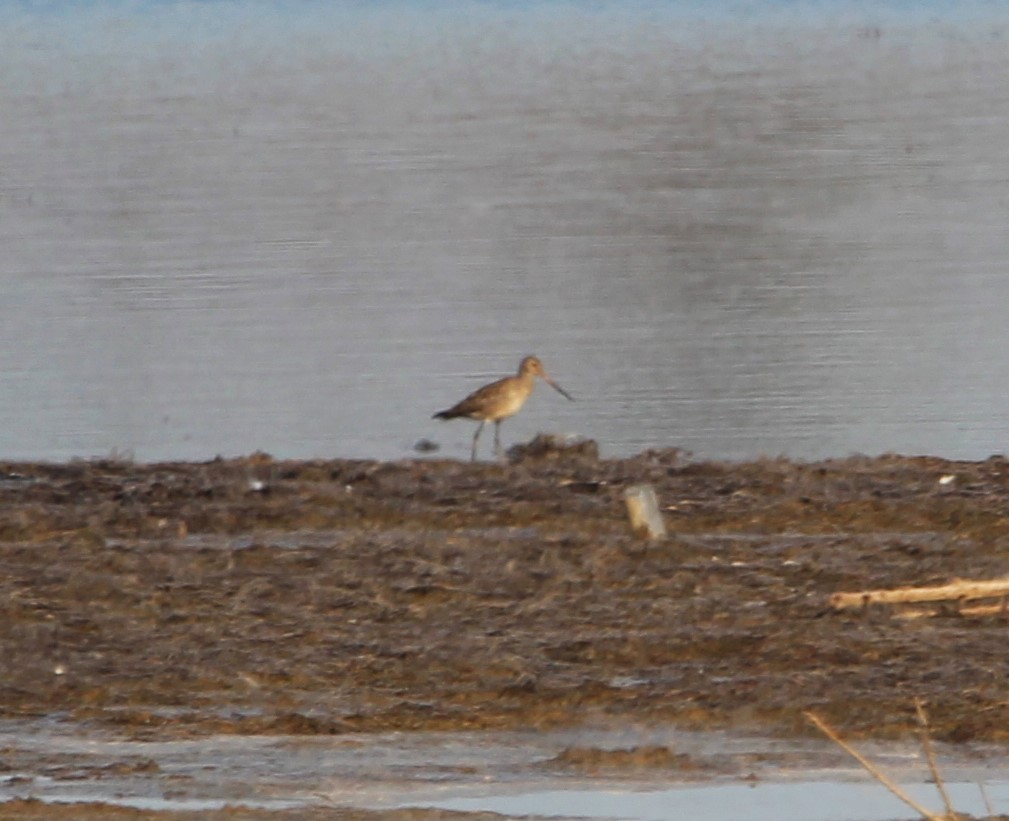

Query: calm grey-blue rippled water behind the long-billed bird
0,2,1009,460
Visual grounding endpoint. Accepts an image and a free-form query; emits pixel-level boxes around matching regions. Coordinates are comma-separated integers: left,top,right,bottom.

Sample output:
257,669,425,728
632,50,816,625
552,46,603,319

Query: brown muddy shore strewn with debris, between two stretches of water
0,447,1009,817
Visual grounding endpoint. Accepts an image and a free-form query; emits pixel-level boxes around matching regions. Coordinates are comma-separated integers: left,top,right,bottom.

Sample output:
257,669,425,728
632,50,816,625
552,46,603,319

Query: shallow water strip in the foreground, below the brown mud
0,721,1009,821
